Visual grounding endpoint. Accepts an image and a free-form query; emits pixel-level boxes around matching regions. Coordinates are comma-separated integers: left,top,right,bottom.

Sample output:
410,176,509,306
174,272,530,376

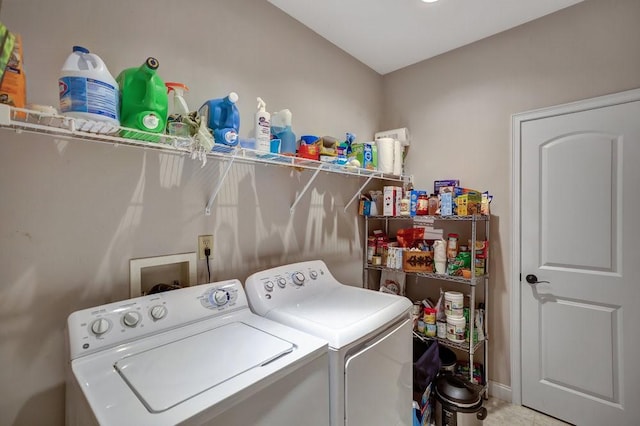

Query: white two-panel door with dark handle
519,96,640,425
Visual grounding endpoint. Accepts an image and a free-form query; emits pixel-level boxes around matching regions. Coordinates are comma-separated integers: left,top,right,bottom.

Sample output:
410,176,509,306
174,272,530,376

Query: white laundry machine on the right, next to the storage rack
245,260,413,426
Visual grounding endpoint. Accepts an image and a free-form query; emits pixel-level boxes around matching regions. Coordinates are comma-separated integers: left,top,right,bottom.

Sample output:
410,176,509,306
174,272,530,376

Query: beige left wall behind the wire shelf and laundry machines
0,0,382,425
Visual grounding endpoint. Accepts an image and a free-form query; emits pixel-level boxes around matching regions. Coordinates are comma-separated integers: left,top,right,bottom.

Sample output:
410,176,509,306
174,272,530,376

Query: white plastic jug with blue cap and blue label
58,46,120,126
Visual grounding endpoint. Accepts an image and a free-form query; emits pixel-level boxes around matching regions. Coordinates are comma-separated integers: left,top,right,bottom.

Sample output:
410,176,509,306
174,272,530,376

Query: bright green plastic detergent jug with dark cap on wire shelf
116,58,169,142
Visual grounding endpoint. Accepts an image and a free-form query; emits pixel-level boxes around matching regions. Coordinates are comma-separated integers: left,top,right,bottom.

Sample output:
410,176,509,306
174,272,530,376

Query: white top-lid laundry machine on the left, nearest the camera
66,280,330,426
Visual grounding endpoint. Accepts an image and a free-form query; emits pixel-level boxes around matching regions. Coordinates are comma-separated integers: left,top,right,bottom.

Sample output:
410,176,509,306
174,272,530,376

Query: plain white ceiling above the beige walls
269,0,582,75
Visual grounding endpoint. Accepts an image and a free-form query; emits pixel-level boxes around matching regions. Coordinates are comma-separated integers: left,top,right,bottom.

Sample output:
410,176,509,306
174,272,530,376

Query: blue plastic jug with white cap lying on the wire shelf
198,92,240,146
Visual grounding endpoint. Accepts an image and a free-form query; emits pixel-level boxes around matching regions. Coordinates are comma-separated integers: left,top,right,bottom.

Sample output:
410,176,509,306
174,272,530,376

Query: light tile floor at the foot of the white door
482,398,568,426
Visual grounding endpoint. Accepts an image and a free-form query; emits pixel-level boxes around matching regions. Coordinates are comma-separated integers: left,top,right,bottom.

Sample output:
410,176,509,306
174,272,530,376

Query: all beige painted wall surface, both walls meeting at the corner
5,0,640,424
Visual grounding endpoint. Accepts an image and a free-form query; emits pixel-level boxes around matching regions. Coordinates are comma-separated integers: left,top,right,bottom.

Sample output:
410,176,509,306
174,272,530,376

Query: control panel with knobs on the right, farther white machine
245,260,342,315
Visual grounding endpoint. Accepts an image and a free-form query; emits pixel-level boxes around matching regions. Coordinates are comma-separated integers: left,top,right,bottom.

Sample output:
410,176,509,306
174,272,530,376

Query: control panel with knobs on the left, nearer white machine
67,280,249,359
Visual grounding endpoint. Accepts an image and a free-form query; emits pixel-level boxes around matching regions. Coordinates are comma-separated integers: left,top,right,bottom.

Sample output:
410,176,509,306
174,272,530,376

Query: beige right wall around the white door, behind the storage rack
382,0,640,386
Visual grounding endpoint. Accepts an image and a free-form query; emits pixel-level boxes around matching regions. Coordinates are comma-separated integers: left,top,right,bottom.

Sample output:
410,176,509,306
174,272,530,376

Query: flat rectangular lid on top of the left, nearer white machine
114,322,294,413
